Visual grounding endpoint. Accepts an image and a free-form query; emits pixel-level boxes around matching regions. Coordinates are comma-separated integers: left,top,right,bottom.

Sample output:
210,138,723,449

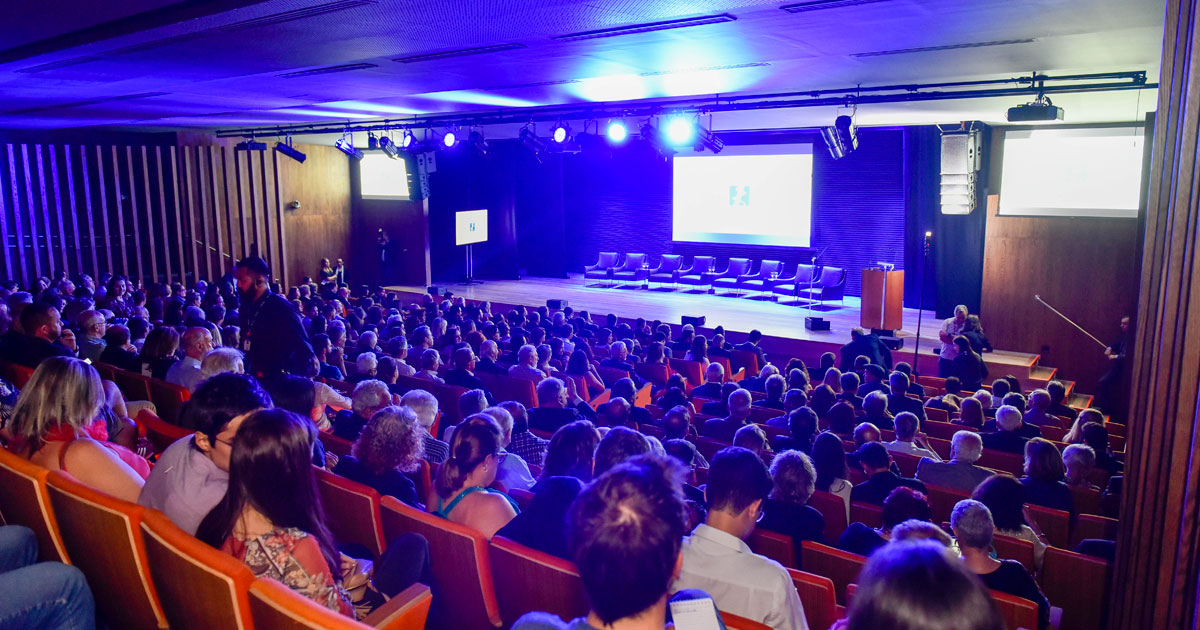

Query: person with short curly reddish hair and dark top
334,406,425,508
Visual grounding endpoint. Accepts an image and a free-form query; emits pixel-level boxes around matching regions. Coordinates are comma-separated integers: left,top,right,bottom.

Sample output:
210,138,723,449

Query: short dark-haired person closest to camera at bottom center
512,456,686,630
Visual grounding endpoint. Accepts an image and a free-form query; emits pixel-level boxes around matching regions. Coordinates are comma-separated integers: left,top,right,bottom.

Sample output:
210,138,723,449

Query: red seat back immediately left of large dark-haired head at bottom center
487,536,588,624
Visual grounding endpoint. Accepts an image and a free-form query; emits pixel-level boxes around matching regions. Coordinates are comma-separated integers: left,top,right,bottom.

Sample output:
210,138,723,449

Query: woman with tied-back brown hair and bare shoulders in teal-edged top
426,414,517,539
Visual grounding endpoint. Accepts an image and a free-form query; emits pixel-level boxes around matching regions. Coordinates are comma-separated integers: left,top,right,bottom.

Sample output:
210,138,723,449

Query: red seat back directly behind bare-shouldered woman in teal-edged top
380,497,500,629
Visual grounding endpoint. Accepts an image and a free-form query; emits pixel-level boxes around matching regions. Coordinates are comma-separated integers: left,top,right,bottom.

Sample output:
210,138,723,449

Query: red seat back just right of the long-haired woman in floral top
313,467,388,559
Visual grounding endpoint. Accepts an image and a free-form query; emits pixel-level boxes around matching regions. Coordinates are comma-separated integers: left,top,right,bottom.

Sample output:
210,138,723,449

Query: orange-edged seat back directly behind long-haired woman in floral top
142,510,254,630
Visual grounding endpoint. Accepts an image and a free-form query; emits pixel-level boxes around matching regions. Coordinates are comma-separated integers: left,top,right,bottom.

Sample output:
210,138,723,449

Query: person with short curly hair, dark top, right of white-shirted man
758,451,826,566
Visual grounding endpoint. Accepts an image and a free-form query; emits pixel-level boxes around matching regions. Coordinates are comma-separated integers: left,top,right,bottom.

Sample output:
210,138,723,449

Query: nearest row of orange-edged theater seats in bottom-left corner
0,449,432,630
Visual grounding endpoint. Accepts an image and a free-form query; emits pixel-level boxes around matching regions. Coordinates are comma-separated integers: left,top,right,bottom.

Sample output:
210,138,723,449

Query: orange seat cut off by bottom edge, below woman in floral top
250,578,433,630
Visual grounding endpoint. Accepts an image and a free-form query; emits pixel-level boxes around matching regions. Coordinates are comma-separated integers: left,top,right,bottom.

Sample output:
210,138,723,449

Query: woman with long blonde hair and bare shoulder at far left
12,356,144,503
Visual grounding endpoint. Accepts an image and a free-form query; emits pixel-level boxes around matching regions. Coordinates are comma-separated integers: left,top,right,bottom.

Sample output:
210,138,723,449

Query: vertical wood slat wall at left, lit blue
0,143,289,287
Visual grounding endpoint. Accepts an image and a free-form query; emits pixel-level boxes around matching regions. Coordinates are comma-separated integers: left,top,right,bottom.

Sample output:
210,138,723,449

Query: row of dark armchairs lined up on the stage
583,252,846,302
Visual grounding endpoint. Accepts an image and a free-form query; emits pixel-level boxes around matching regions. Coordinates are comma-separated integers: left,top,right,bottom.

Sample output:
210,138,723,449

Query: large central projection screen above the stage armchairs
671,144,812,247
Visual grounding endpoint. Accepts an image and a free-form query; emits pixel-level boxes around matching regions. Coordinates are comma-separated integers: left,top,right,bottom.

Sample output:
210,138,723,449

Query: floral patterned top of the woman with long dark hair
221,527,354,618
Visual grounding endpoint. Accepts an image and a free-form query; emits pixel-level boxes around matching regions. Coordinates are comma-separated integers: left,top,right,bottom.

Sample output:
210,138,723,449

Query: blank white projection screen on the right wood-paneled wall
998,126,1144,218
